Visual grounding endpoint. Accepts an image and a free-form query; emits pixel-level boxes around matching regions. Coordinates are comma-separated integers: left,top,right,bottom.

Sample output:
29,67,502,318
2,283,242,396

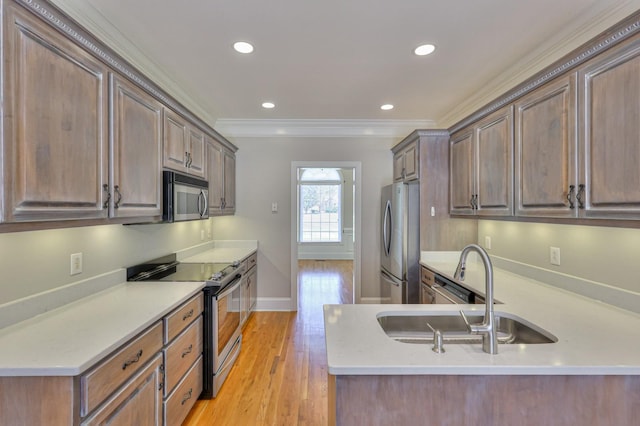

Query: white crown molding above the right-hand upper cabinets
438,0,638,132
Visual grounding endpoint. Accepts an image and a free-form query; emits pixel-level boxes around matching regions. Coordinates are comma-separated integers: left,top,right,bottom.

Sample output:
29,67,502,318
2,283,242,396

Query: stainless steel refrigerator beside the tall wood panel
380,182,420,303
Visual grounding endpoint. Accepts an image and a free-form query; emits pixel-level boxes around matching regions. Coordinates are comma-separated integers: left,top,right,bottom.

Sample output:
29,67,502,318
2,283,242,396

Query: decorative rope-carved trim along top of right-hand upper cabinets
449,12,640,134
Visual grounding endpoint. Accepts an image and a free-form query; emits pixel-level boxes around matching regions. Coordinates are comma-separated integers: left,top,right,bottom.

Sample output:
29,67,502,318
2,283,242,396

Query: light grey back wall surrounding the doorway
211,137,396,300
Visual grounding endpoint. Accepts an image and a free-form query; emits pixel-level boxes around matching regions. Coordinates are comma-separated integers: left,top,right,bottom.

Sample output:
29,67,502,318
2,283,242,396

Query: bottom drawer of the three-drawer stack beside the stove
163,357,202,425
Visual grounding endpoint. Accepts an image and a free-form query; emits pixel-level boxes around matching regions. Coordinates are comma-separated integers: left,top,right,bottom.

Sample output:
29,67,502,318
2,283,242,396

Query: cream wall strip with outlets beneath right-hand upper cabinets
478,220,640,293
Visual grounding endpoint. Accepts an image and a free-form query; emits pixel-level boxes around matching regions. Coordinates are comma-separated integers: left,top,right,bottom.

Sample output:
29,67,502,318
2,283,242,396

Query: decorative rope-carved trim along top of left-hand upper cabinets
14,0,238,152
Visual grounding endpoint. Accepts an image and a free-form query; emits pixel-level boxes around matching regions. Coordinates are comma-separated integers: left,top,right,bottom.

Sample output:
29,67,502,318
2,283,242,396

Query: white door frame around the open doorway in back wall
291,161,362,311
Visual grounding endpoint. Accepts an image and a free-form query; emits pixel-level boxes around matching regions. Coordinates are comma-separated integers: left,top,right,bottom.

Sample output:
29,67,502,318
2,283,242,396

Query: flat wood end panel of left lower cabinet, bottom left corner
0,376,80,426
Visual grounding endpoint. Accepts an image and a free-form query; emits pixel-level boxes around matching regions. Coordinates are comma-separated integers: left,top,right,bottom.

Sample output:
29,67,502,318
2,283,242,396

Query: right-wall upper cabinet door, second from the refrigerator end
476,106,513,216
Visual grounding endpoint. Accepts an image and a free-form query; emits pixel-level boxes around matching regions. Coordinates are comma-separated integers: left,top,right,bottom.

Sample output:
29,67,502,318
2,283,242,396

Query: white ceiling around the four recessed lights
54,0,640,135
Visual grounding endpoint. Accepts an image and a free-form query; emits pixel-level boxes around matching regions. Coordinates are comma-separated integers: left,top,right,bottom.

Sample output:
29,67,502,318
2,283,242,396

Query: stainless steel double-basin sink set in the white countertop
378,312,558,344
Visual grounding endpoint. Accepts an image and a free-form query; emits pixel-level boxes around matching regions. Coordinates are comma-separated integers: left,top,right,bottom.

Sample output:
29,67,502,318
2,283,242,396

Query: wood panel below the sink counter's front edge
328,374,640,426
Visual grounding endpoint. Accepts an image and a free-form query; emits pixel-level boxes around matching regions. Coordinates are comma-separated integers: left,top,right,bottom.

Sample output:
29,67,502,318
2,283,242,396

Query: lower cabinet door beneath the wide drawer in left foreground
82,353,162,426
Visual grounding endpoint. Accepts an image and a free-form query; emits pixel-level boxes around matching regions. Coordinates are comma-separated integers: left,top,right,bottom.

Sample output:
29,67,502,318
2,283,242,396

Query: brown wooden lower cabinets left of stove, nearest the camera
0,293,203,426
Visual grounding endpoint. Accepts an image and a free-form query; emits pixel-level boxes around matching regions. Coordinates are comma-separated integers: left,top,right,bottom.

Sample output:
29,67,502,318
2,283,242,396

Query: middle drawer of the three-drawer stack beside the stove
164,316,202,396
